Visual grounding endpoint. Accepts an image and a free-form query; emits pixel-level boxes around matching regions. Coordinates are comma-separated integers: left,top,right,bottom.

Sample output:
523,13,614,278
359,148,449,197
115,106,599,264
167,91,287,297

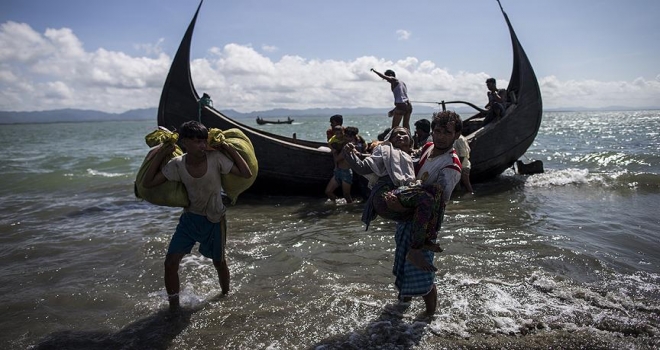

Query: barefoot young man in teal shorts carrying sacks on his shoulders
143,120,252,311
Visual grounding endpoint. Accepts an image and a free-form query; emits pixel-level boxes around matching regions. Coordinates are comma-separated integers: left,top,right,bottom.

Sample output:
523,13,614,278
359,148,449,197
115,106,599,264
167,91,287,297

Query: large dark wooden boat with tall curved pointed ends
158,0,541,196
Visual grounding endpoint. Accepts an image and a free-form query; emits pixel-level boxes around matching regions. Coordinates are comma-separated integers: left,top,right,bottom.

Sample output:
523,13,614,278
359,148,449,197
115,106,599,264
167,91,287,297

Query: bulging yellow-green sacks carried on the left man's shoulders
134,127,259,207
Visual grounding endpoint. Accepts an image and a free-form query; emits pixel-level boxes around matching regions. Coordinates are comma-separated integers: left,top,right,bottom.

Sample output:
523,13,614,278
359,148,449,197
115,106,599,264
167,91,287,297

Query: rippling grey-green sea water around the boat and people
0,111,660,349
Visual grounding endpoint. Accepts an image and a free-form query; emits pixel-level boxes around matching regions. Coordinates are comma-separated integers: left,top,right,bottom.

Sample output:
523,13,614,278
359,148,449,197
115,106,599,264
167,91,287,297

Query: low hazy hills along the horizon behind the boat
0,104,657,124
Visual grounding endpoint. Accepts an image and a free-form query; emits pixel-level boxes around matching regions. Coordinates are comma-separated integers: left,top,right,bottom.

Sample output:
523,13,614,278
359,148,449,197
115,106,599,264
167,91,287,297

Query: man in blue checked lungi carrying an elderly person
389,111,463,315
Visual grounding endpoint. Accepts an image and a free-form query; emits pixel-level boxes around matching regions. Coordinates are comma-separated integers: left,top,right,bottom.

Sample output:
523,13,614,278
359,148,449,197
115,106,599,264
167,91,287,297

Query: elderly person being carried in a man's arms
343,126,452,258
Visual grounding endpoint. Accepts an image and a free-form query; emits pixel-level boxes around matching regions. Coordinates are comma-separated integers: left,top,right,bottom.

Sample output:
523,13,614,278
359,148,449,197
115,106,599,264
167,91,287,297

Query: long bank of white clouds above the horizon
0,22,660,112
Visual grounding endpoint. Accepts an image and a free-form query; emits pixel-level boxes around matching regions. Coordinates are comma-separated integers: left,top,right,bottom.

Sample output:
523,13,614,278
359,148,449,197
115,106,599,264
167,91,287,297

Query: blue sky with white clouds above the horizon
0,0,660,113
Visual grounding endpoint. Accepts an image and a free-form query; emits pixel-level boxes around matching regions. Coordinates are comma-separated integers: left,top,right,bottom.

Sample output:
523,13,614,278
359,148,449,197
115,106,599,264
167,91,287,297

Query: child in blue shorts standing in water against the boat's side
325,125,355,203
